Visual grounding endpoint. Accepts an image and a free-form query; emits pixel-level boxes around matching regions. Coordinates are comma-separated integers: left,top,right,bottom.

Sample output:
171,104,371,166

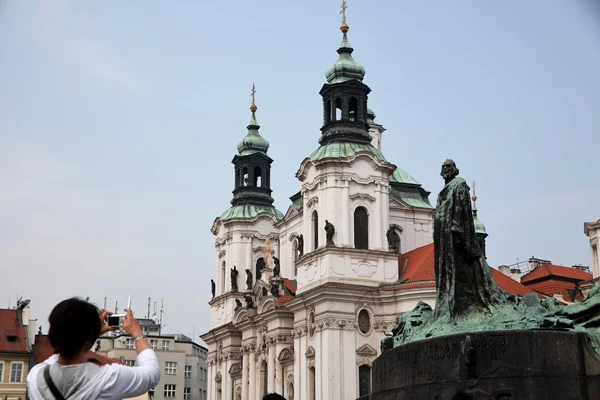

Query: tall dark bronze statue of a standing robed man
433,160,502,318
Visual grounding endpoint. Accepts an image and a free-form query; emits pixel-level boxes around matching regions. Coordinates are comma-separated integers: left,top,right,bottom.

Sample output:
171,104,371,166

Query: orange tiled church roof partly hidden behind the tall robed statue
390,243,535,296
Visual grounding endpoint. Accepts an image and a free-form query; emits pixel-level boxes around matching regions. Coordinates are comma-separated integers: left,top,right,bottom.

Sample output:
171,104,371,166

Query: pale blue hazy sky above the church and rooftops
0,0,600,341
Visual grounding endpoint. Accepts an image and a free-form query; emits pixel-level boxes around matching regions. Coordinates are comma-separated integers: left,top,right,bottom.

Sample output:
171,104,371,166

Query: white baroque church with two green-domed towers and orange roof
201,7,531,400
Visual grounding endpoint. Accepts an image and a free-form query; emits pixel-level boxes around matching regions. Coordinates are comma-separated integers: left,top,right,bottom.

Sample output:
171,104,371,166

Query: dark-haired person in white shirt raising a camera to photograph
27,298,160,400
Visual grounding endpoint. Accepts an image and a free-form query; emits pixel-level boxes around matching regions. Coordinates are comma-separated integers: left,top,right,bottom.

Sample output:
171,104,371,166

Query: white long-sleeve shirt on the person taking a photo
27,349,160,400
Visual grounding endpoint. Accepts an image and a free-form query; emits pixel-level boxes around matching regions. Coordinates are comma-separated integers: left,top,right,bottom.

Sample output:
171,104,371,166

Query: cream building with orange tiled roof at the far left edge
0,300,36,400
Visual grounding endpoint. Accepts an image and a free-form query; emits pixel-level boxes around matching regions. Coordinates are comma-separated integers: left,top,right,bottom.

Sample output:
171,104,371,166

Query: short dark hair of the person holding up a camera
48,297,101,359
